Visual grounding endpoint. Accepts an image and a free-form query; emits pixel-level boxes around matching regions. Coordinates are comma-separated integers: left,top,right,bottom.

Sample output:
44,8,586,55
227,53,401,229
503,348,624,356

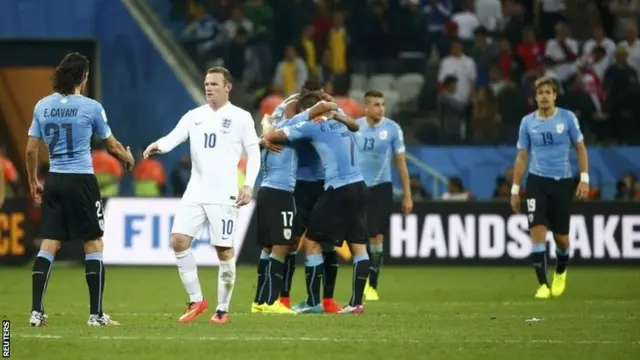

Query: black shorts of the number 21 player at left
40,173,104,241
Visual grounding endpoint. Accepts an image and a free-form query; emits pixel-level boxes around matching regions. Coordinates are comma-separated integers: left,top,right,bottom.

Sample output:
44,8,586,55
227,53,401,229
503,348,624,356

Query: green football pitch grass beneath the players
0,265,640,360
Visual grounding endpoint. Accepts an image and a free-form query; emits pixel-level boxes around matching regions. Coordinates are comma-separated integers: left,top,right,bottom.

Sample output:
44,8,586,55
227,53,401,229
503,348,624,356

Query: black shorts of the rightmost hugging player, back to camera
307,181,369,244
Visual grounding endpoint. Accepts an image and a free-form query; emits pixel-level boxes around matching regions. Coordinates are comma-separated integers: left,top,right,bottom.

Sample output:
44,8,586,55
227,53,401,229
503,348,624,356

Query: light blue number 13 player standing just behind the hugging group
356,90,413,301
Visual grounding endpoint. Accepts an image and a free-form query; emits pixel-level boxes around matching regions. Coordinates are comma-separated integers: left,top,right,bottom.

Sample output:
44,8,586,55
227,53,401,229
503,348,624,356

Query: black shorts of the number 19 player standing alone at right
525,174,575,235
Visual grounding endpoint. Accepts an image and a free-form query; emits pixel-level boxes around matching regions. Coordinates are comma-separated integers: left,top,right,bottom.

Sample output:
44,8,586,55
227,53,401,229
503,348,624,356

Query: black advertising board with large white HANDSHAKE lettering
386,202,640,265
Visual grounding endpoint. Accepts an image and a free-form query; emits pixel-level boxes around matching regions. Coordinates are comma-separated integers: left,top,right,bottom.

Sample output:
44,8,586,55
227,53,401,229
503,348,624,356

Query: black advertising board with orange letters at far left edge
0,199,34,265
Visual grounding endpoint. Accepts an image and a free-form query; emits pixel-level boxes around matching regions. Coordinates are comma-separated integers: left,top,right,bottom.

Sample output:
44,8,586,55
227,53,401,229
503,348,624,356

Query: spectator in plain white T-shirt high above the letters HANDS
438,40,477,104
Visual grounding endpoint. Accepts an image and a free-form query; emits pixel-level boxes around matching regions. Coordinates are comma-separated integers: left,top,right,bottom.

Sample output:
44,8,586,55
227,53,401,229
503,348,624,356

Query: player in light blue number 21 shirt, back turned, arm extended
26,53,134,326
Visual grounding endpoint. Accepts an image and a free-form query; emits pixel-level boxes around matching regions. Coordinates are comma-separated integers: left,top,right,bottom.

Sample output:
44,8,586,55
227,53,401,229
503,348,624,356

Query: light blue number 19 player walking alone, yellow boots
511,77,589,299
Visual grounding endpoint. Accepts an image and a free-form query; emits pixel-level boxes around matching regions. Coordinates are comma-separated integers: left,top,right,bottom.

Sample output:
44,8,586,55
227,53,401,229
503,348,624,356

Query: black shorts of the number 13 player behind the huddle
367,182,393,237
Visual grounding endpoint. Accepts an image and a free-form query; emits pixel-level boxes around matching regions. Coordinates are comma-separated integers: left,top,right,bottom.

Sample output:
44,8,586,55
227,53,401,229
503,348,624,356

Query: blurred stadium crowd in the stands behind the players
0,0,640,205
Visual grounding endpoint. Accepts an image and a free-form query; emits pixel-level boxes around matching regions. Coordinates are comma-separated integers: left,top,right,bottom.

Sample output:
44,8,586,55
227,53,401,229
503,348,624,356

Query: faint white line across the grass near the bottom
13,334,640,345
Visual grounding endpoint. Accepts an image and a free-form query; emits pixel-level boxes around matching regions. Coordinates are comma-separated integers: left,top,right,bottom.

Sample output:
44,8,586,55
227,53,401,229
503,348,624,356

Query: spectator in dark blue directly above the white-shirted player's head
182,3,227,69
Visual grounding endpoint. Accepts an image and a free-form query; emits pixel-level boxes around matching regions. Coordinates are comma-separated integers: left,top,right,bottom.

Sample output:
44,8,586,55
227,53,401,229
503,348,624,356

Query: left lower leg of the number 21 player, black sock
29,239,60,326
